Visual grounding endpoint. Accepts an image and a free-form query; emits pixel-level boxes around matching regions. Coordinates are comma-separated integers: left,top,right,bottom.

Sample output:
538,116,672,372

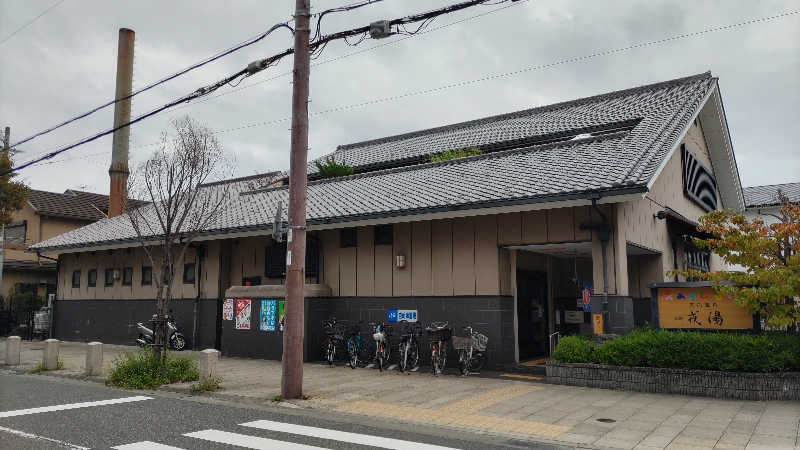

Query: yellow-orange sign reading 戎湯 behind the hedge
658,287,753,330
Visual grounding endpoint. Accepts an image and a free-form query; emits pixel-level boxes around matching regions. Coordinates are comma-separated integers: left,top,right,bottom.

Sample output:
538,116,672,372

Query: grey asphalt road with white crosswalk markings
0,373,554,450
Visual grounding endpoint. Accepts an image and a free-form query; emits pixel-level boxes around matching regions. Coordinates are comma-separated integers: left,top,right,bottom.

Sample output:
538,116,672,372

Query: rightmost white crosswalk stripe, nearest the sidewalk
240,420,460,450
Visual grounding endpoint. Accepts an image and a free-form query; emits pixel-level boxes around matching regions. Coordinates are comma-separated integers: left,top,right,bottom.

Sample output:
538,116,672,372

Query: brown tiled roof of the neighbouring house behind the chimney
28,189,143,221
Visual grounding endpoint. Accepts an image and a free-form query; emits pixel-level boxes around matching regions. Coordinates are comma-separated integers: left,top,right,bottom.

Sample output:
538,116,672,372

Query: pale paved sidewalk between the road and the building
0,340,800,450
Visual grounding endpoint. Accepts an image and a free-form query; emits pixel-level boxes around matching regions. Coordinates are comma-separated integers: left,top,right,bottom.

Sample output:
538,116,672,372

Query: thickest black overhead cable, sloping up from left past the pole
0,0,515,176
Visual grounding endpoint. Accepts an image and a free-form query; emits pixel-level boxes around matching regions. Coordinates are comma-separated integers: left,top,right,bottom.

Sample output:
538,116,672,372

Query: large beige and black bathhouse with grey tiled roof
31,73,744,364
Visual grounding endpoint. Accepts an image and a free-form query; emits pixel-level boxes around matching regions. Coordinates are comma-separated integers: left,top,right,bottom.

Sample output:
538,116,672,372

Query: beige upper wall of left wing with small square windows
58,241,220,300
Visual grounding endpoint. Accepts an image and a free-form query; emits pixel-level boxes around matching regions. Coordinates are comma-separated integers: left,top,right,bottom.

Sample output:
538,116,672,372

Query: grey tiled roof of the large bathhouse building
34,73,716,250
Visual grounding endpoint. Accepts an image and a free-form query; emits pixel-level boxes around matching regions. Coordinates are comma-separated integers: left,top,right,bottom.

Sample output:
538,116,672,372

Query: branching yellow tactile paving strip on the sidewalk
336,385,570,437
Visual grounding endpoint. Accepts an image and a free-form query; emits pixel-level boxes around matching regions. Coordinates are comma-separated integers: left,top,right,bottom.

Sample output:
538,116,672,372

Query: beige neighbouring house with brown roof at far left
0,189,145,306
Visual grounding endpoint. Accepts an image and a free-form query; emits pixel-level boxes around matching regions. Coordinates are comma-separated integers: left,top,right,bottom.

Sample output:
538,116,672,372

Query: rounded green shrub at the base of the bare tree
106,348,200,389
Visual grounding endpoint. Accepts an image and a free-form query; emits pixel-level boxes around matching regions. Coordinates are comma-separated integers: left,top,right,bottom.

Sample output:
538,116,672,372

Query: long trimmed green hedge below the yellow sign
553,329,800,372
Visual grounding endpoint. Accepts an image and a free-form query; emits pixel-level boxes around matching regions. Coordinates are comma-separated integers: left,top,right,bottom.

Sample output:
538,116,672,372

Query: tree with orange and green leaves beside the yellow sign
675,192,800,329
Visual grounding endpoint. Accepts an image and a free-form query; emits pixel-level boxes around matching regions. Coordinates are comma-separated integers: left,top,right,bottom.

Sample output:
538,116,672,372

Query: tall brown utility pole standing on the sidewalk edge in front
281,0,311,398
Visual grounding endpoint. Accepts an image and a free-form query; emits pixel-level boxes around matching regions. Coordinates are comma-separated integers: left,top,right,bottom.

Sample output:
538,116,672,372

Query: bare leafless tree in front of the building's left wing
128,116,233,355
